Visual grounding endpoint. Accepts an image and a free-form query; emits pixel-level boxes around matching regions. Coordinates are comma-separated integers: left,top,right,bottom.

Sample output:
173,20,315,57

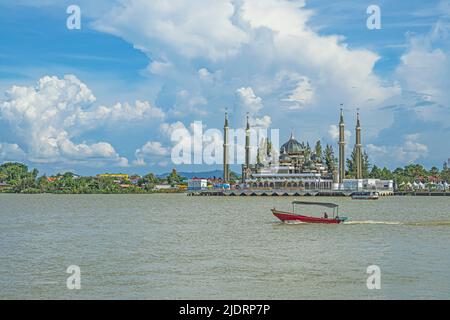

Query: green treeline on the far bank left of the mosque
0,163,184,194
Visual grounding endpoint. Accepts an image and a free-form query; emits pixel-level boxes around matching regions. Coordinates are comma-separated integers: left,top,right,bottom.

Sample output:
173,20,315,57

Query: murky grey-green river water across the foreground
0,194,450,299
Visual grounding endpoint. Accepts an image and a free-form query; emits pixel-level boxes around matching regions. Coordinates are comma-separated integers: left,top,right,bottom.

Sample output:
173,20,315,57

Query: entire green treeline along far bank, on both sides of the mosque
0,159,450,194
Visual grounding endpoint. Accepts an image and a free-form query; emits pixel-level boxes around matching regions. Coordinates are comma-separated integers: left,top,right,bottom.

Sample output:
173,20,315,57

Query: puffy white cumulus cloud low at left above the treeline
0,75,165,166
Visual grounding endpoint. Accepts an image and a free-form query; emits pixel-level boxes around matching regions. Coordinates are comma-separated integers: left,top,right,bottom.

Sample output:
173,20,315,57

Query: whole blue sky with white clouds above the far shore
0,0,450,174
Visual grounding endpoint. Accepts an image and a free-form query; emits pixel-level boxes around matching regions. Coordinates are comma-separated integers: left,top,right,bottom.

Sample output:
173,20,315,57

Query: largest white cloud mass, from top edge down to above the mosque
91,0,400,146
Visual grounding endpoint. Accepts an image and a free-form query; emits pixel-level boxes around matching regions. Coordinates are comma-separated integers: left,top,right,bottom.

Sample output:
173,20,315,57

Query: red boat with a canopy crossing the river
272,201,347,224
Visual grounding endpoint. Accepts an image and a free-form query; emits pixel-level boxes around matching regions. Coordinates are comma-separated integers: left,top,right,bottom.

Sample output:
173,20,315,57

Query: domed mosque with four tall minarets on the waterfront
223,109,393,191
